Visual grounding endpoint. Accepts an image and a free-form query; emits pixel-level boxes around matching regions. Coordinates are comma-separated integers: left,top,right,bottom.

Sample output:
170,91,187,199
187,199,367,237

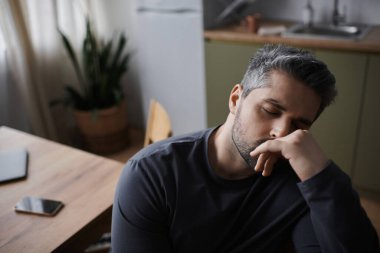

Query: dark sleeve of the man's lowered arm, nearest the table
111,161,172,253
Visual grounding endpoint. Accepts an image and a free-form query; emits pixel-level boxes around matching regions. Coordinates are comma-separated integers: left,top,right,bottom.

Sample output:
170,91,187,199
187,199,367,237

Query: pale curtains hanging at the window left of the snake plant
0,0,101,145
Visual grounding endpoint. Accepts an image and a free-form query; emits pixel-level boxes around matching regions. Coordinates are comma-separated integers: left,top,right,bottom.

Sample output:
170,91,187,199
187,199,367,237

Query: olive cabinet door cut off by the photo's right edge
353,55,380,193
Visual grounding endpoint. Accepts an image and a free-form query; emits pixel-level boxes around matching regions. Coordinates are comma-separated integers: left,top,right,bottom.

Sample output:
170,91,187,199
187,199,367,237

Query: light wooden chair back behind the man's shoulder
144,99,172,147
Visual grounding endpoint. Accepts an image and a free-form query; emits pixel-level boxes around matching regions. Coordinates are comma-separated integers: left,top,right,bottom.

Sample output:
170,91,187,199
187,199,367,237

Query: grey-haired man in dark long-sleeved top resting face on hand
112,46,379,253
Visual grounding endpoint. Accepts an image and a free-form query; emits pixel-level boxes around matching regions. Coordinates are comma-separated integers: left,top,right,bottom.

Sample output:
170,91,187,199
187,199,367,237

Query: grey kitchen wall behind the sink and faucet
203,0,380,29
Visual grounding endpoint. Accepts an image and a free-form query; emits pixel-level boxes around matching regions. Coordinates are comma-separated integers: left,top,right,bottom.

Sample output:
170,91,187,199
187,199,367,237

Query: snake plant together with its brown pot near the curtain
53,18,129,154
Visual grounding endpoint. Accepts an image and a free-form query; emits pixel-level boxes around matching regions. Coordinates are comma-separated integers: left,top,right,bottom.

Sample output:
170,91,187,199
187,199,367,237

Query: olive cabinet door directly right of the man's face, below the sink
311,50,367,175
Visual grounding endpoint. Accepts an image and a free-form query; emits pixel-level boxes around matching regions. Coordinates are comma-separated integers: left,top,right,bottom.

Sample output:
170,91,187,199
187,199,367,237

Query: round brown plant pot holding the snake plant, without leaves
74,100,128,154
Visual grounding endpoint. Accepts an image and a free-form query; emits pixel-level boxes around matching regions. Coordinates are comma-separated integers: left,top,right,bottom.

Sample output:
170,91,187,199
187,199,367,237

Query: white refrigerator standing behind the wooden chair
134,0,207,135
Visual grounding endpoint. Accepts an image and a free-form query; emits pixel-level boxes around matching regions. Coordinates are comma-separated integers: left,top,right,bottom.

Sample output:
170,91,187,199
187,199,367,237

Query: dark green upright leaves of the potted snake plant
53,17,129,110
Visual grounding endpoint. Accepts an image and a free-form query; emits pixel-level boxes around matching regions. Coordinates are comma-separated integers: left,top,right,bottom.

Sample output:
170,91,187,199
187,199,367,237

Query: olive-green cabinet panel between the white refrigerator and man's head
205,41,260,127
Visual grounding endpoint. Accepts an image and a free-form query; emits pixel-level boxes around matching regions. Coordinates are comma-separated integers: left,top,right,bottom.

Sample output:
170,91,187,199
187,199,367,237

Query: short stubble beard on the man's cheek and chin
232,106,270,169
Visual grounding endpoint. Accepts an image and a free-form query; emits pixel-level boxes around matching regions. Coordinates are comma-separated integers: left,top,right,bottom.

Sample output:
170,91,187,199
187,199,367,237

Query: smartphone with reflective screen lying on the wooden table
15,196,64,216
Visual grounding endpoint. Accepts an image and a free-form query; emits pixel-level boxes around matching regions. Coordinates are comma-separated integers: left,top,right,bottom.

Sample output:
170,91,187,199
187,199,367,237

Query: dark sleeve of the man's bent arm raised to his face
298,162,380,253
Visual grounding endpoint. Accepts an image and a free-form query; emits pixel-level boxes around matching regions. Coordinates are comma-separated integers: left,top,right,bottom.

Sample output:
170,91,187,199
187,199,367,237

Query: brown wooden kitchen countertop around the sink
204,22,380,54
